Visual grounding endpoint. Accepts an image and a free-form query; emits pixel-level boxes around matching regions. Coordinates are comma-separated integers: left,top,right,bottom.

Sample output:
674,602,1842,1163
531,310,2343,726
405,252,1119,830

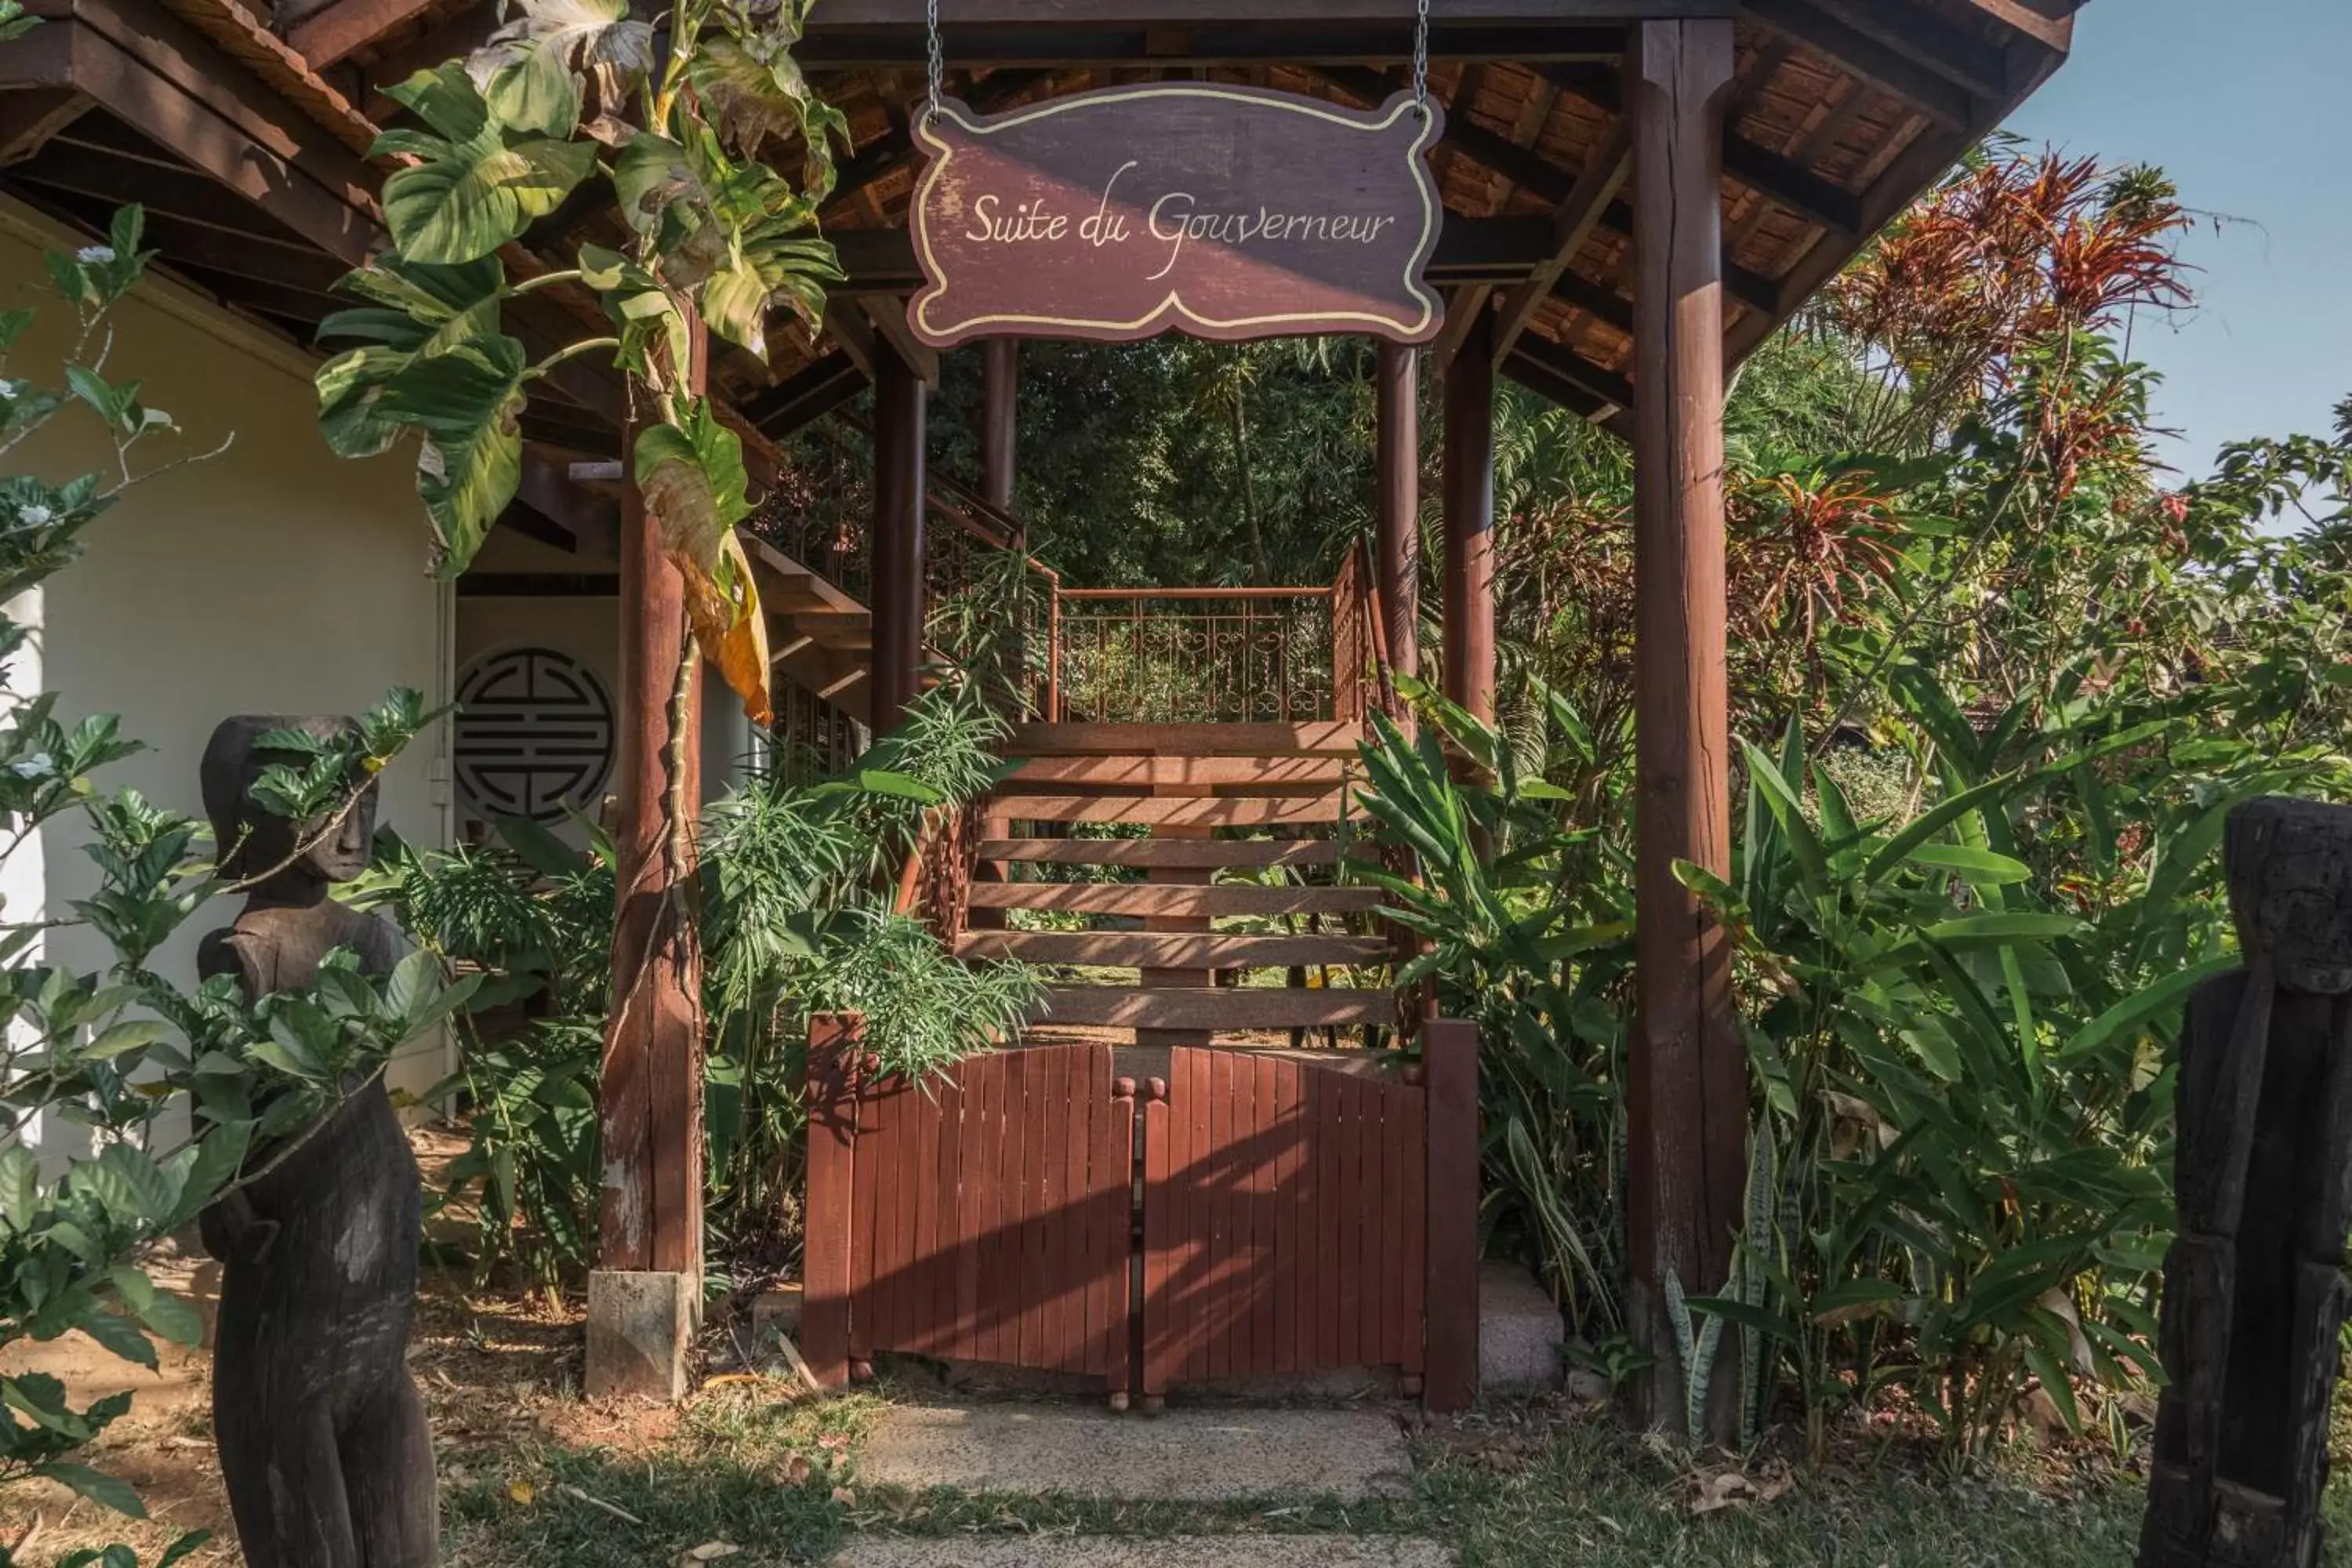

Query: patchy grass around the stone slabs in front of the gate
447,1385,2352,1568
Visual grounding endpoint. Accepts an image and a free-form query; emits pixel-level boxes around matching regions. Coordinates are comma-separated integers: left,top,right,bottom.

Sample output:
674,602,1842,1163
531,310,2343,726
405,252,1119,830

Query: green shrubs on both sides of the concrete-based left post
372,682,1040,1290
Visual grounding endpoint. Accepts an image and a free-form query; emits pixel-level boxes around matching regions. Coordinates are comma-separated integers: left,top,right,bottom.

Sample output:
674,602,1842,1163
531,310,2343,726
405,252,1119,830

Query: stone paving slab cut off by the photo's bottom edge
833,1535,1454,1568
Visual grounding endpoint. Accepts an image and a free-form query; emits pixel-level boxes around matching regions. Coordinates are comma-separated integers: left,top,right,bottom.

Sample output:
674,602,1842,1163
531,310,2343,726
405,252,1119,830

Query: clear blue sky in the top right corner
2009,0,2352,477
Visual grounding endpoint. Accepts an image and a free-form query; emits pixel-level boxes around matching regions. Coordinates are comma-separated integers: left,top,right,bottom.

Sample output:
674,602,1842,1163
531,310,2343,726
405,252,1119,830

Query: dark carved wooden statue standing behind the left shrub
198,715,437,1568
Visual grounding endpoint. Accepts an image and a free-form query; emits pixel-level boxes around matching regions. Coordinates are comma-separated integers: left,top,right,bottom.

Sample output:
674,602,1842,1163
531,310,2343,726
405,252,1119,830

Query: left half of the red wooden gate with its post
804,1018,1134,1394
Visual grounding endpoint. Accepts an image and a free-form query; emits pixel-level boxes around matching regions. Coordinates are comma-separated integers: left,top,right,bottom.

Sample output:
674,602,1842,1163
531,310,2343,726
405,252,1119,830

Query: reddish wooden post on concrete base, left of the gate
588,322,708,1399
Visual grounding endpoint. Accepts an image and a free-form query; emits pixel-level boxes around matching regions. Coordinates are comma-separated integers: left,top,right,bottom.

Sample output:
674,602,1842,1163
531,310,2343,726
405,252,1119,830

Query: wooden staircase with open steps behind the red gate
957,722,1397,1046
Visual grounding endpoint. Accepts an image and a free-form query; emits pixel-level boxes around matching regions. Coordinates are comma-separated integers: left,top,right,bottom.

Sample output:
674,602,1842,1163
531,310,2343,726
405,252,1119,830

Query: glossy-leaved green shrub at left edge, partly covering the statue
0,211,470,1568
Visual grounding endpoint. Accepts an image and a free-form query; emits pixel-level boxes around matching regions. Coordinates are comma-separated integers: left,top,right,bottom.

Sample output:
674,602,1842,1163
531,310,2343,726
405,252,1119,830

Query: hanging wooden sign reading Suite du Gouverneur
908,82,1444,348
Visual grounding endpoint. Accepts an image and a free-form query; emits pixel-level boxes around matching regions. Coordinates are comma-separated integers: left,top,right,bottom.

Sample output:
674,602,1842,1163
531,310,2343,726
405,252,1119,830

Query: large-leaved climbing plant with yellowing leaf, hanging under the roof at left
318,0,847,722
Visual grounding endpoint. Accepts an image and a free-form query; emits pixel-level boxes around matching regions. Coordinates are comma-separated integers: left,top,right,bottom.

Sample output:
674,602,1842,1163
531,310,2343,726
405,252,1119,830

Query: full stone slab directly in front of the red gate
858,1403,1414,1504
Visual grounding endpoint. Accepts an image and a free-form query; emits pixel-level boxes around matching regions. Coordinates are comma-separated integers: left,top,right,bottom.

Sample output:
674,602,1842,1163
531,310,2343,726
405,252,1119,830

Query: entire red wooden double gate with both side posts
802,1018,1477,1410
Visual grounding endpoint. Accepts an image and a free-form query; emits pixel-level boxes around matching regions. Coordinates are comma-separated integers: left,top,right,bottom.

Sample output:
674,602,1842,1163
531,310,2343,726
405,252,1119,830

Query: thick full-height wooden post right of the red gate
1625,19,1748,1441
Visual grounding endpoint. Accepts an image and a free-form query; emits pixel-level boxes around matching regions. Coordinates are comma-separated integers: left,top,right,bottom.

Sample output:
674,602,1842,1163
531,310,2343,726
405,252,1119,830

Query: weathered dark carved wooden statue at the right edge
2140,799,2352,1568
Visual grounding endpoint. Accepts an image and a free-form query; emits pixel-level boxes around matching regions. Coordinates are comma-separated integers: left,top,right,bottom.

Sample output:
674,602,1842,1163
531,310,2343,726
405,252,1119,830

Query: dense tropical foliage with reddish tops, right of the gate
1369,148,2352,1457
